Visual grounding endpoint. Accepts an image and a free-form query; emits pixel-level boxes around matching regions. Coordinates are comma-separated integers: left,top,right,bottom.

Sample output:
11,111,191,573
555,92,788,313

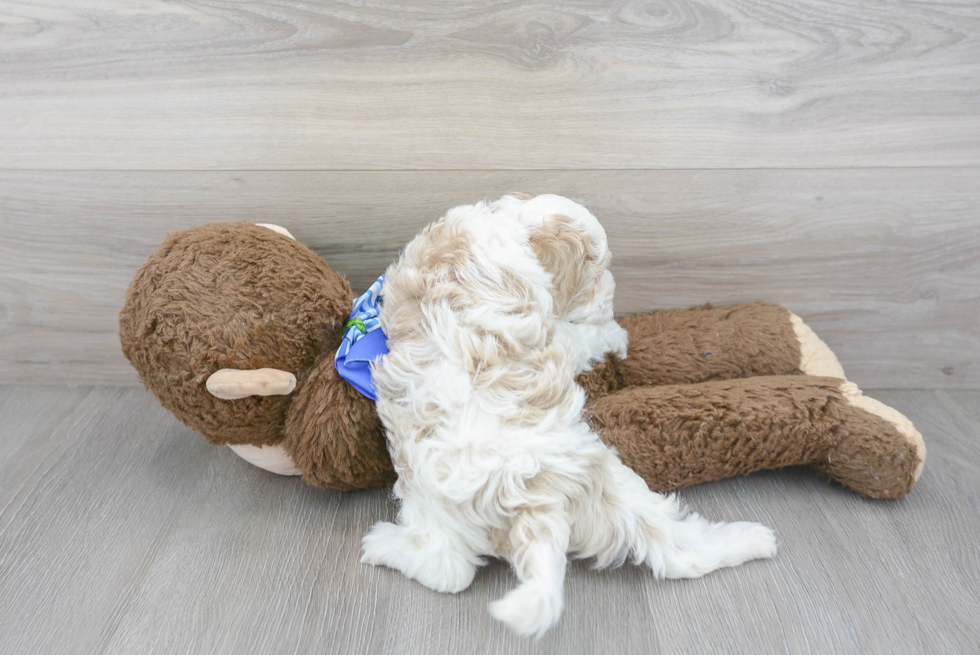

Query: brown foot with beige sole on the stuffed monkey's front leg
818,382,926,498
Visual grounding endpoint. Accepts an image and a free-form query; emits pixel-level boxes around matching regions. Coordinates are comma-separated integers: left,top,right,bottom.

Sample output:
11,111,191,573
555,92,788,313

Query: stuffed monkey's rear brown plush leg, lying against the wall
580,302,844,397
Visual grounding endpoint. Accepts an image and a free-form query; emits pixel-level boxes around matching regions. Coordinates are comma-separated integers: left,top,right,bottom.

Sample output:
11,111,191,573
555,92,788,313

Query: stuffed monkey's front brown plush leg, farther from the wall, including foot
591,375,925,498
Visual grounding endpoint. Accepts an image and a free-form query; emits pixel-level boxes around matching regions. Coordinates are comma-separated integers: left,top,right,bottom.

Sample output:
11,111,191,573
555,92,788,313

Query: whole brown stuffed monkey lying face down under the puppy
119,223,925,498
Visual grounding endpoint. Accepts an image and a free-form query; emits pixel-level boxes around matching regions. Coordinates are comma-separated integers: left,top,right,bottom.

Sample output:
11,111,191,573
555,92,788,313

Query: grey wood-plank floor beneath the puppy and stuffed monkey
0,386,980,655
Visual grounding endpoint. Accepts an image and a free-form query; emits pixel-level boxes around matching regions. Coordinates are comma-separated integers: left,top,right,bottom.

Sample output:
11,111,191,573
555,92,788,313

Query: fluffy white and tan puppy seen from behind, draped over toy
361,195,776,635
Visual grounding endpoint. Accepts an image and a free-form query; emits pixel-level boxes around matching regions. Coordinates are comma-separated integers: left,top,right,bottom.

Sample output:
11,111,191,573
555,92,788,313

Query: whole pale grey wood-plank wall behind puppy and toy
0,0,980,387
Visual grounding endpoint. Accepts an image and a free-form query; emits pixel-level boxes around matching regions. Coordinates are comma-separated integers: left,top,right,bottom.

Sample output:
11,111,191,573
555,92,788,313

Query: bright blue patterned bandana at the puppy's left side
334,275,388,400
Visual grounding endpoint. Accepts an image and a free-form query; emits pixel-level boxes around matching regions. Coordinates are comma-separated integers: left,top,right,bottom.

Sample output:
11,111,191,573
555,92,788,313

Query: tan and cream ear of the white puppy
531,214,597,316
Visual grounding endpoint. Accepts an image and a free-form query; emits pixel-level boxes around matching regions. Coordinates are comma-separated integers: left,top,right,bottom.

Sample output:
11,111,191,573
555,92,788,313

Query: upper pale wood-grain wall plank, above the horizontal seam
0,0,980,170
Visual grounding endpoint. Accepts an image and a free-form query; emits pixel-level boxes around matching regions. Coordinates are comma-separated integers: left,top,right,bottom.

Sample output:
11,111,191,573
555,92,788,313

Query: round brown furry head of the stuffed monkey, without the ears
119,223,351,446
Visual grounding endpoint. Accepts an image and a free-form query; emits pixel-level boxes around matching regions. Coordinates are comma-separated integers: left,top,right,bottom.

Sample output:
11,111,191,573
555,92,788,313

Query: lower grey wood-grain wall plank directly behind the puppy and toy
0,169,980,388
